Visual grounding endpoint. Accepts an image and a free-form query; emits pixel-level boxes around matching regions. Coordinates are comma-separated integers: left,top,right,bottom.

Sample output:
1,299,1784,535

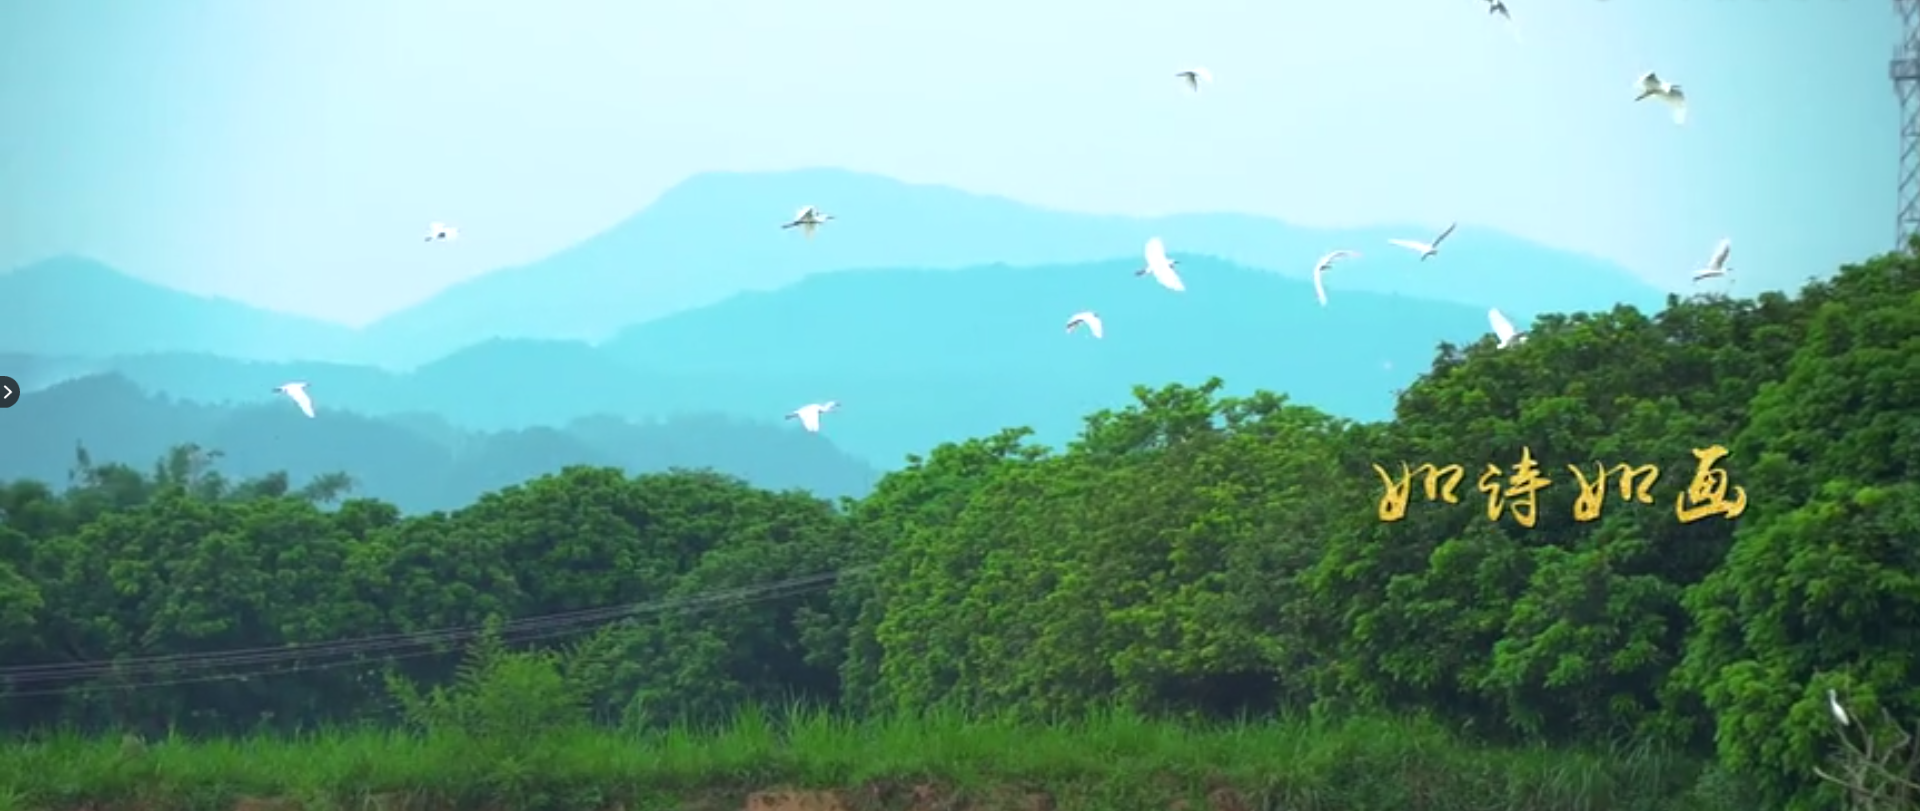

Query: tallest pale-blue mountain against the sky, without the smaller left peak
349,167,1661,365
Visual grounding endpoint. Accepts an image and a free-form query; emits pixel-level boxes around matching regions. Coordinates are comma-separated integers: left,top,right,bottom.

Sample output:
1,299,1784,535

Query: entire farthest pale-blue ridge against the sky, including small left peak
0,169,1663,369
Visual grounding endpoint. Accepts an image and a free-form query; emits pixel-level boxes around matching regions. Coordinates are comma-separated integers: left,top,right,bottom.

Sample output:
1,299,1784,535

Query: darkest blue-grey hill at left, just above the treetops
0,375,877,511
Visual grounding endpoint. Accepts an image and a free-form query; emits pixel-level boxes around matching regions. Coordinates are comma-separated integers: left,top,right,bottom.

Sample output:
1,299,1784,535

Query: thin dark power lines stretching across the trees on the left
0,565,872,698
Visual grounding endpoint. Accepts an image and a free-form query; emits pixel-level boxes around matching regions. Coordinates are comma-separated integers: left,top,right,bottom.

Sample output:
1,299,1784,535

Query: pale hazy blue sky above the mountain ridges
0,0,1897,323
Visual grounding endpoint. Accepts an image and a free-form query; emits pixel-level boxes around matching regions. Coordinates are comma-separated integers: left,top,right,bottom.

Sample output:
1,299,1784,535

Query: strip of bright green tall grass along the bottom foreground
0,711,1743,811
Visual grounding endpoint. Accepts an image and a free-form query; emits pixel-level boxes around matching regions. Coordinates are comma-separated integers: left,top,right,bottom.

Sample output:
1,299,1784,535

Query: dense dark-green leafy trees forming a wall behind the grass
0,247,1920,807
